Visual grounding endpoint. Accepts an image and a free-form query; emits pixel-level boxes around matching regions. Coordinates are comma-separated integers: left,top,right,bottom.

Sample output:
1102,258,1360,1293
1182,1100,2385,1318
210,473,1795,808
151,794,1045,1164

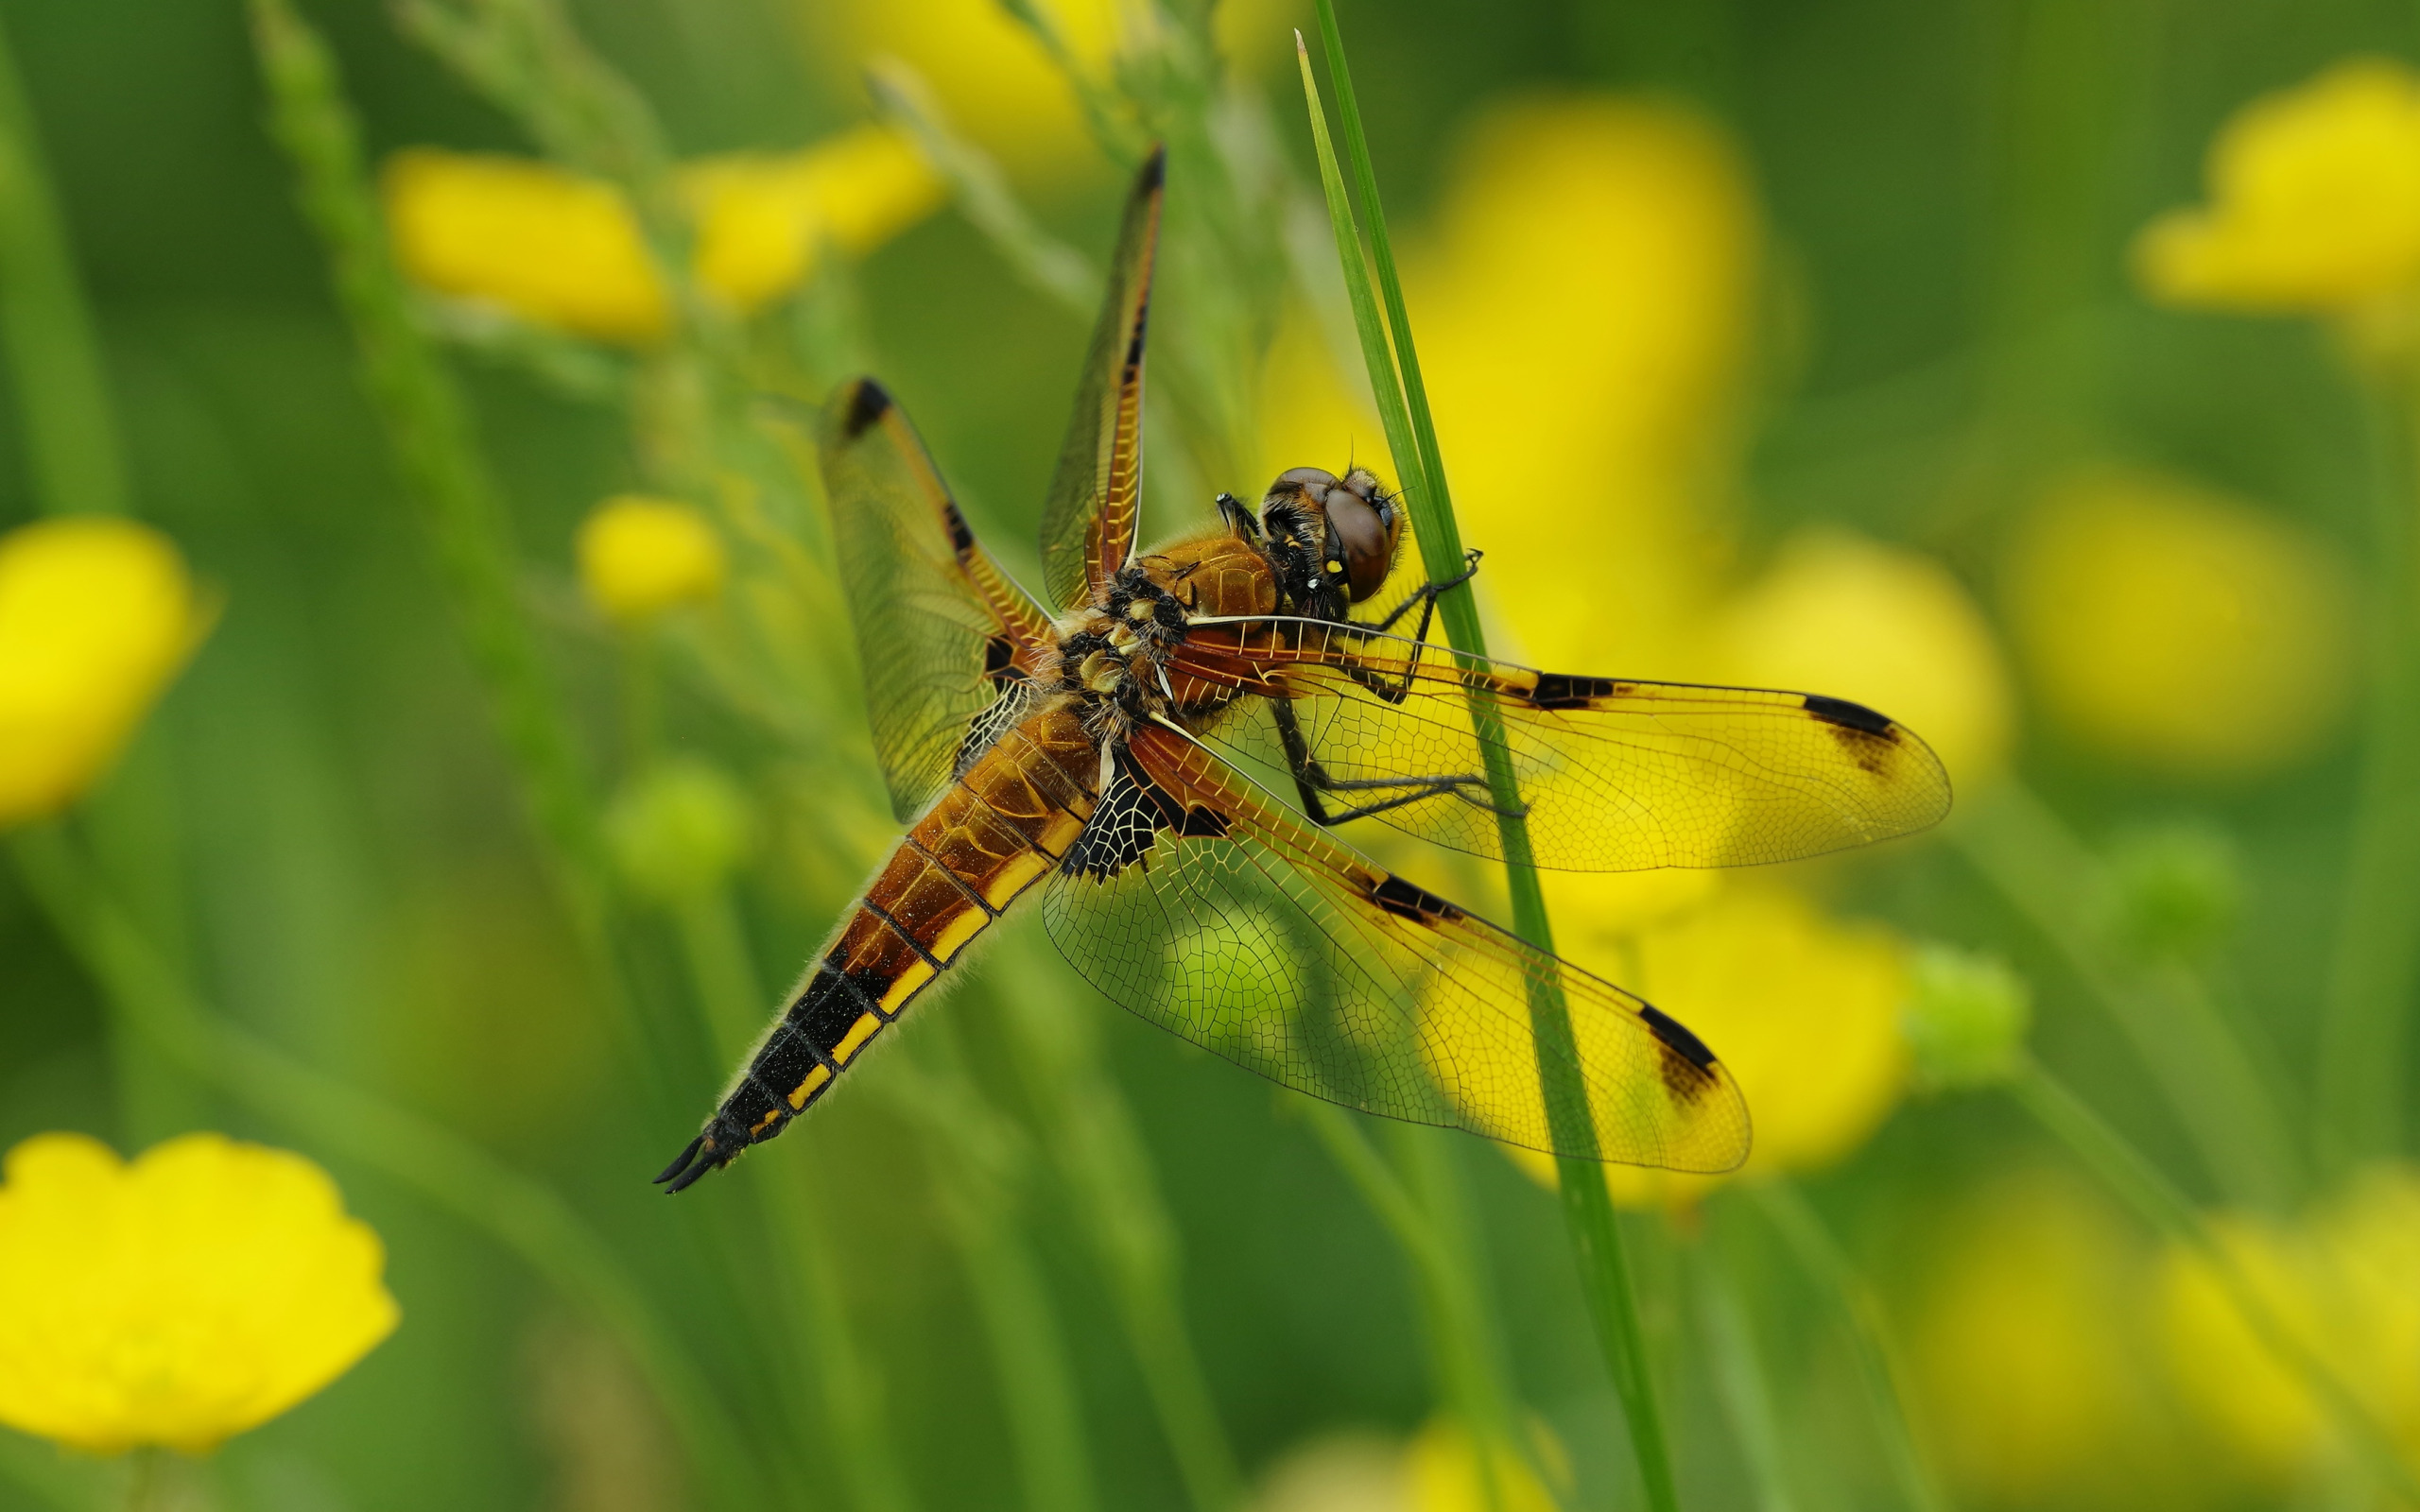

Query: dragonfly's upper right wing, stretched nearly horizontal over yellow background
1171,619,1950,871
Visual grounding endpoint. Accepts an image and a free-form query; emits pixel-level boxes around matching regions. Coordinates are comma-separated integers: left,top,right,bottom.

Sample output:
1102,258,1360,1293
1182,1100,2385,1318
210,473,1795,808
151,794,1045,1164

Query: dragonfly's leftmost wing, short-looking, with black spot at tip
816,377,1053,820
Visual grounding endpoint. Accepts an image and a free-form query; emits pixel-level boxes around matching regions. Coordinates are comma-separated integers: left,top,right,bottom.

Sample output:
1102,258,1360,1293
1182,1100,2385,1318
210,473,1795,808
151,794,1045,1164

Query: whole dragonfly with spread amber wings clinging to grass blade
656,152,1950,1193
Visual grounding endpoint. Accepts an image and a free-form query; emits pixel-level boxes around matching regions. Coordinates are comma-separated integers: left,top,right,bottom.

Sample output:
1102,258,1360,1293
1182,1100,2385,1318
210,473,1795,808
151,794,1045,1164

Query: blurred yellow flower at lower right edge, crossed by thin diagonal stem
2159,1171,2420,1486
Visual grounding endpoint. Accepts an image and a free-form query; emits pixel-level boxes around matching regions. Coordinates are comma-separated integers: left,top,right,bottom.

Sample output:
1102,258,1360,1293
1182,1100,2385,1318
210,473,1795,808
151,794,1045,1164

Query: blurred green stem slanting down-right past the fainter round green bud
1948,779,2304,1212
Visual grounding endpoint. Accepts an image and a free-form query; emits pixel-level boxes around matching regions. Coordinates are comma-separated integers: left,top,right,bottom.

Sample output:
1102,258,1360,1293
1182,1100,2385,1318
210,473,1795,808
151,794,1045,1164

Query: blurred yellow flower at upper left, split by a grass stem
382,126,942,344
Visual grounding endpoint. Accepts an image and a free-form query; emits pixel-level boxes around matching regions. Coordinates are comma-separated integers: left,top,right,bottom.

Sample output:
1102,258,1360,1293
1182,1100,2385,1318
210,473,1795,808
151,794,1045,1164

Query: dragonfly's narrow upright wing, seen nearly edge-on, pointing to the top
1043,147,1167,610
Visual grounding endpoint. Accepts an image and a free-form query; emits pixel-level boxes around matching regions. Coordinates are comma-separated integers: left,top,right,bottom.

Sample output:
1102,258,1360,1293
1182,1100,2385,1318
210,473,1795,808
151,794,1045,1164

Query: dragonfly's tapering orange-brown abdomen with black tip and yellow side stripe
658,712,1098,1193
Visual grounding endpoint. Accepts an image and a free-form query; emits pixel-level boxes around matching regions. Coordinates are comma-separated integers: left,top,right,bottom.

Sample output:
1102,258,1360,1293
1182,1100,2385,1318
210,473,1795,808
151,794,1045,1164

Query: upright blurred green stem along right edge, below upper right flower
2313,375,2420,1174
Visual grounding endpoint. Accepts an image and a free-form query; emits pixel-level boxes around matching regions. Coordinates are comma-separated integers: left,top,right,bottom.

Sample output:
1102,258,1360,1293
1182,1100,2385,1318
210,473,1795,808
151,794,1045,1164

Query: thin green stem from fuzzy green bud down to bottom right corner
2006,1059,2420,1507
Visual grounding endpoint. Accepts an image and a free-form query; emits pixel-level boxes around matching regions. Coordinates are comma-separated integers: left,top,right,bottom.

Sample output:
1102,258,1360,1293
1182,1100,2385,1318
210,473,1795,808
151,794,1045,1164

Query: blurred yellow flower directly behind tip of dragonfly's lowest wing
1512,883,1910,1207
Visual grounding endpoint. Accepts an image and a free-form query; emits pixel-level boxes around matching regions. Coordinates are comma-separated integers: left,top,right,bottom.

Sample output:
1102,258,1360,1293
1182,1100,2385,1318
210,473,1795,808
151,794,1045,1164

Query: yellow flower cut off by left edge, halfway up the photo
0,515,211,828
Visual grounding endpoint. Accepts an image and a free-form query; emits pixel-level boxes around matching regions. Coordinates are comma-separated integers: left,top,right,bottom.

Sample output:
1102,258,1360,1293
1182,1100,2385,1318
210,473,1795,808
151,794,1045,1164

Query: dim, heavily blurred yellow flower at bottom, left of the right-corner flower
1910,1171,2181,1512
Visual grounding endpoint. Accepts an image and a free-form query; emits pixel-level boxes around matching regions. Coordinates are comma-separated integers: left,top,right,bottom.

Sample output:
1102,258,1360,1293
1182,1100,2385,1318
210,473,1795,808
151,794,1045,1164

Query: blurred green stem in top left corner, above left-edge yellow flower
0,7,126,515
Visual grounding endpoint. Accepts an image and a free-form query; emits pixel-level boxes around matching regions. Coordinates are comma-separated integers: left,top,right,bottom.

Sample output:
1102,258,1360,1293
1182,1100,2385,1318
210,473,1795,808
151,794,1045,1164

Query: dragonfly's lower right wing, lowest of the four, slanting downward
1043,729,1747,1171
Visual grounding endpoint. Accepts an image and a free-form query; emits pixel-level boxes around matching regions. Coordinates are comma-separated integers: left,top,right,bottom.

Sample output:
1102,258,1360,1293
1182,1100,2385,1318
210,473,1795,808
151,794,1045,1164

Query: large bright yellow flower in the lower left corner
0,1135,399,1454
